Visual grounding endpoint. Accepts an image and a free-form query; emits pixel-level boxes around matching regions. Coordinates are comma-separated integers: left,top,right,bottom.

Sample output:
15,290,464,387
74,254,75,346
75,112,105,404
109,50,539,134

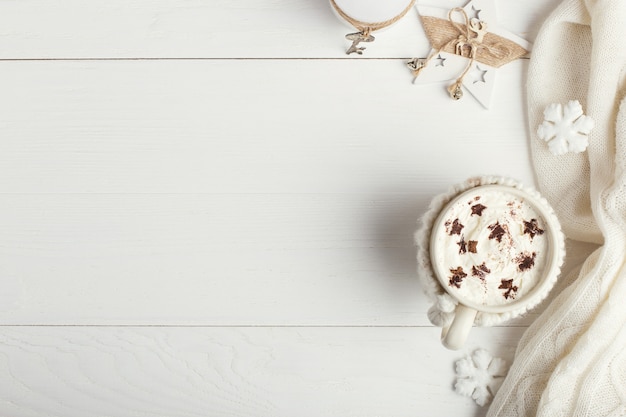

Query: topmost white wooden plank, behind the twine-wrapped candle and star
0,0,558,59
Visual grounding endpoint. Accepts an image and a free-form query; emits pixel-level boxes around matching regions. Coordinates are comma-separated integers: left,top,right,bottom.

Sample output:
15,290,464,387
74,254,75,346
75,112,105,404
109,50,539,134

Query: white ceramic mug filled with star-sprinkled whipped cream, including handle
430,184,564,349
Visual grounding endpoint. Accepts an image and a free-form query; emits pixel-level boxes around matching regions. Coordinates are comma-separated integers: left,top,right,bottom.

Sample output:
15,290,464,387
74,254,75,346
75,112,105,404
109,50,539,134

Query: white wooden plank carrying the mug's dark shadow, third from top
0,193,586,326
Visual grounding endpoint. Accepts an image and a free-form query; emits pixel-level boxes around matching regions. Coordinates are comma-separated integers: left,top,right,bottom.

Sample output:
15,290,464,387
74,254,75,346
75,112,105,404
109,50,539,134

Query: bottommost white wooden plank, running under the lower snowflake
0,327,522,417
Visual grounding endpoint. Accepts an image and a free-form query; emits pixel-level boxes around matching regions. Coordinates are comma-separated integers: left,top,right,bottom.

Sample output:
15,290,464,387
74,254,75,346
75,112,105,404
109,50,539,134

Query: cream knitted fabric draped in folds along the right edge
488,0,626,417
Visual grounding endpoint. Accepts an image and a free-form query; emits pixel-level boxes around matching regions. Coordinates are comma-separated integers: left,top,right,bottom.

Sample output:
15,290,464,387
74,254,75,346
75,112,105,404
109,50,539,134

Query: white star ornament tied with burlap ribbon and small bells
409,0,531,108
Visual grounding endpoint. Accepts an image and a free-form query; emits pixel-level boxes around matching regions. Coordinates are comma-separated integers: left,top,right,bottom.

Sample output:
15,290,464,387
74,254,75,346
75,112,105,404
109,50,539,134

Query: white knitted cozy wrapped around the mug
415,176,565,327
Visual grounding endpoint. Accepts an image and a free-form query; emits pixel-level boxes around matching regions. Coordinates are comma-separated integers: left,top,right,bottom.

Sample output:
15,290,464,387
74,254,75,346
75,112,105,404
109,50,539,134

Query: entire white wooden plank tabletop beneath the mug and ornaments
0,0,576,417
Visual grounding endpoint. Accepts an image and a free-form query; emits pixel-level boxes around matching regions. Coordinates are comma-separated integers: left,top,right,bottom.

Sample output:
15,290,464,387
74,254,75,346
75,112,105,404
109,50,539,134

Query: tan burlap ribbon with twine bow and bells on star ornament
408,7,528,100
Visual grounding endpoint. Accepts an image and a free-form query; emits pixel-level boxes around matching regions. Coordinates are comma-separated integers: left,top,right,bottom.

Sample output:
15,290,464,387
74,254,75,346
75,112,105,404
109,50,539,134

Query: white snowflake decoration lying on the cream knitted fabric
537,100,594,155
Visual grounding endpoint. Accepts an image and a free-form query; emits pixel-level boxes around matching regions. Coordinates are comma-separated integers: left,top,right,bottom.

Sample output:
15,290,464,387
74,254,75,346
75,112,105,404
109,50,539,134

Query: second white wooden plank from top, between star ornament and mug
0,60,533,194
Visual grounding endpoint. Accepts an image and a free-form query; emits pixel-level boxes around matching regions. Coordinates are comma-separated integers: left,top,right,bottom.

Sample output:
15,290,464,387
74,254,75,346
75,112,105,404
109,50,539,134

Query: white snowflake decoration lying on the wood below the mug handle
454,349,508,406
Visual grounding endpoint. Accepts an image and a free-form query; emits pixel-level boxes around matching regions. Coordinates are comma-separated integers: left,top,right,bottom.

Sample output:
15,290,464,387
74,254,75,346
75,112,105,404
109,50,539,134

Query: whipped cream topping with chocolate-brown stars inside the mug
431,187,549,306
